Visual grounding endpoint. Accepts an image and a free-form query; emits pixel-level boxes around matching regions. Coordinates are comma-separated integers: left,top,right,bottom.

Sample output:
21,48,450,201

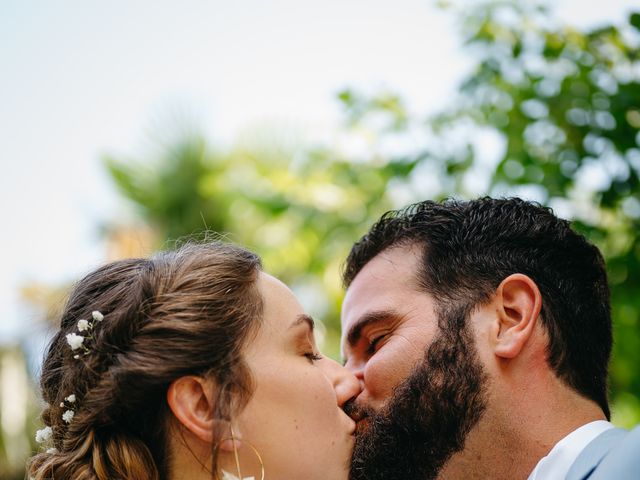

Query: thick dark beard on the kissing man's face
345,314,487,480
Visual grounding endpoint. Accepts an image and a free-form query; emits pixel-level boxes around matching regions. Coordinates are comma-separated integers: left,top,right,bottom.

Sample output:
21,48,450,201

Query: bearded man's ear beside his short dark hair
494,273,542,358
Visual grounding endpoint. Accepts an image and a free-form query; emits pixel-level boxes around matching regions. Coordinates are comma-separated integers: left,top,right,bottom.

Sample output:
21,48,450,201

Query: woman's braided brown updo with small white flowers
28,242,262,480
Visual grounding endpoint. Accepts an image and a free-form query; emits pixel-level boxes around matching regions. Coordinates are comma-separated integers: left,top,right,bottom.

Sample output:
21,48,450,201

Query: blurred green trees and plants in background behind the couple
0,1,640,478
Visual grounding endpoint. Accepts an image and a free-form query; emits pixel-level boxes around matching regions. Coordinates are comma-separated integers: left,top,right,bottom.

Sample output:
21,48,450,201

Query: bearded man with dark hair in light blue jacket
342,198,640,480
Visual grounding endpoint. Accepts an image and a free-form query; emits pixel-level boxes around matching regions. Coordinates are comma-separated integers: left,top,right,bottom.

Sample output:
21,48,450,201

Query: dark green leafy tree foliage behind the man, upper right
444,2,640,424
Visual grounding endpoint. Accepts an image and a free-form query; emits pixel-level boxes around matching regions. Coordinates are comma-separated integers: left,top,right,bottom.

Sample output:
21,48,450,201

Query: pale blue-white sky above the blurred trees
0,0,635,344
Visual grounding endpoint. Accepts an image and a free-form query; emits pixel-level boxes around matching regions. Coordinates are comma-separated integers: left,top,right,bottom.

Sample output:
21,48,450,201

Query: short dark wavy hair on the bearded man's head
343,198,612,418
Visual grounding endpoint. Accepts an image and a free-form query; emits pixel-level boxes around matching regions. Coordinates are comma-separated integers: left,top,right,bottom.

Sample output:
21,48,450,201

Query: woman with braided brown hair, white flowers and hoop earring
28,243,359,480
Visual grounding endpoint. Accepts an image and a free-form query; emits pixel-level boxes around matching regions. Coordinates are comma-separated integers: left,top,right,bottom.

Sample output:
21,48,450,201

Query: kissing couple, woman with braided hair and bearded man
27,198,640,480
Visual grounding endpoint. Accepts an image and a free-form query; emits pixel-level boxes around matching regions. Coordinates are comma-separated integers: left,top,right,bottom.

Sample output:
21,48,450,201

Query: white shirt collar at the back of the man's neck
528,420,613,480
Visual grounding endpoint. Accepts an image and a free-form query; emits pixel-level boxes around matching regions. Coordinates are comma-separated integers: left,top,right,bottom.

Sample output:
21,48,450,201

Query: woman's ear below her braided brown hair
167,375,216,443
